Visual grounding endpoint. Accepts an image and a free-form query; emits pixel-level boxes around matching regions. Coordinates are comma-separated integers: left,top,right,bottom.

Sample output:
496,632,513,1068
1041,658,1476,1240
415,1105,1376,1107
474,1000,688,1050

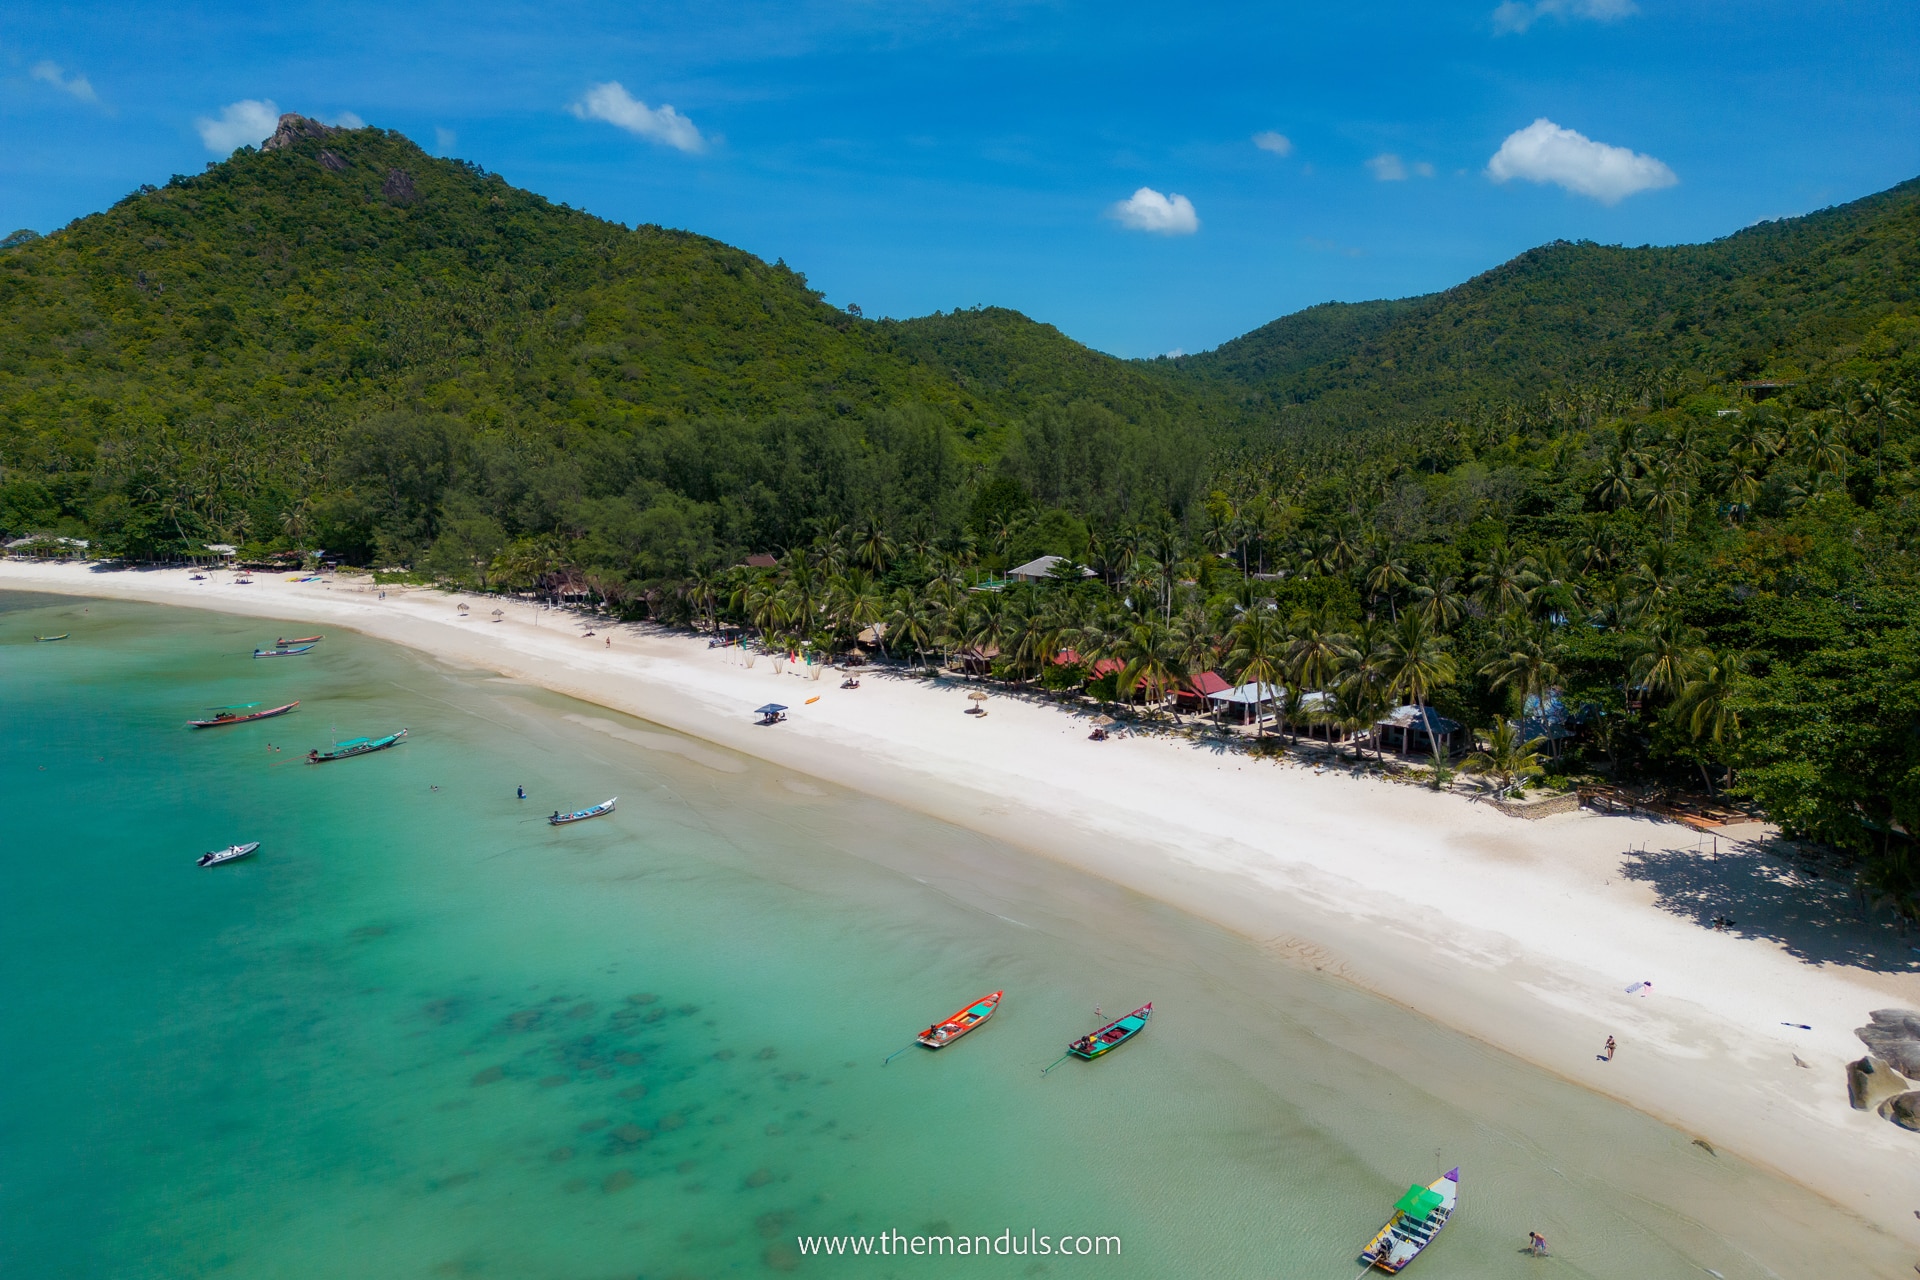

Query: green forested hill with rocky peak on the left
0,117,1194,564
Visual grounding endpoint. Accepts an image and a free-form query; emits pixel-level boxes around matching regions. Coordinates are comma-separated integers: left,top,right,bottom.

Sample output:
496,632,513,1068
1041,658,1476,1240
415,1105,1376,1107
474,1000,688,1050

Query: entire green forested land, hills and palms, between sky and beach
0,117,1920,901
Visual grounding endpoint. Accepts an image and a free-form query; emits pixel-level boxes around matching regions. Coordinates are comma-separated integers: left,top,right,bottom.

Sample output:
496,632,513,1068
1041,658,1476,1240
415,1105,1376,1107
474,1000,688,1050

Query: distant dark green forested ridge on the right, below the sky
1165,178,1920,428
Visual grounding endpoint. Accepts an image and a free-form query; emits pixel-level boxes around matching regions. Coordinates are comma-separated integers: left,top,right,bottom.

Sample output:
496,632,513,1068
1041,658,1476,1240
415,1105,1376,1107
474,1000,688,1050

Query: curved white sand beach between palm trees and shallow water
0,560,1920,1245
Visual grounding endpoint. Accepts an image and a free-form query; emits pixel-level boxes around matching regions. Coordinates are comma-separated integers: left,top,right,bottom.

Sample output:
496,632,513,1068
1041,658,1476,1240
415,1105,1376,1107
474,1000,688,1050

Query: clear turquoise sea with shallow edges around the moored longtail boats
0,593,1907,1280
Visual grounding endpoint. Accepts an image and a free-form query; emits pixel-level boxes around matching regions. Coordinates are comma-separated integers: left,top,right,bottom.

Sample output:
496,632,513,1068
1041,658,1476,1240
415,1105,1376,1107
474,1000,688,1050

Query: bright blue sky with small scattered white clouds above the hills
0,0,1920,355
